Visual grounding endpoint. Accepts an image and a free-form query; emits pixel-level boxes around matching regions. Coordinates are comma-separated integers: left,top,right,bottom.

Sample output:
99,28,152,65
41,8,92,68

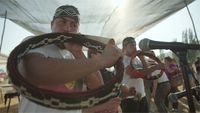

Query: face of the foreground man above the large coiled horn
51,17,79,33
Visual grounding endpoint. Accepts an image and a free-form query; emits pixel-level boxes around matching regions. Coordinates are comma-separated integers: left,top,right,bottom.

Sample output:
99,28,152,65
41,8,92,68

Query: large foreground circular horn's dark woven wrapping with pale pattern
7,33,123,109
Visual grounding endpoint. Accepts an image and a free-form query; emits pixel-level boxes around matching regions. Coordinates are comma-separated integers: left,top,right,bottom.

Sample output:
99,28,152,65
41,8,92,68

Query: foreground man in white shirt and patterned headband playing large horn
18,5,122,113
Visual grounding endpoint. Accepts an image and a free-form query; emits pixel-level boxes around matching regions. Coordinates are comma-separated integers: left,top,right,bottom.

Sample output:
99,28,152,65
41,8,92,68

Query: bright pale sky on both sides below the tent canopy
0,0,200,55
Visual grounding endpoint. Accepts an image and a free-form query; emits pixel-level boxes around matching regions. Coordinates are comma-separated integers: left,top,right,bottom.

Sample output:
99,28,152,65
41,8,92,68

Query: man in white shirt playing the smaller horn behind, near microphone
121,37,164,113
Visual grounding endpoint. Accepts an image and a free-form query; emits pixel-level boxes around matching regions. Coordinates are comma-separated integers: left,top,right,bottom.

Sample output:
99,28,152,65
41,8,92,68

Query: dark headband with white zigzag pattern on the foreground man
53,5,80,23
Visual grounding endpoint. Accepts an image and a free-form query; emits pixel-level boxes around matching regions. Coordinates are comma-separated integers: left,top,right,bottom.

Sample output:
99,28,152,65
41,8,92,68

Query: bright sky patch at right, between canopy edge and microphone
136,0,200,55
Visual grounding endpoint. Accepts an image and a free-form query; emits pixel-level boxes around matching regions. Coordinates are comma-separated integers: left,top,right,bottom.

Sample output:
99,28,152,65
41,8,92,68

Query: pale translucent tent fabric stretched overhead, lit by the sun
0,0,194,42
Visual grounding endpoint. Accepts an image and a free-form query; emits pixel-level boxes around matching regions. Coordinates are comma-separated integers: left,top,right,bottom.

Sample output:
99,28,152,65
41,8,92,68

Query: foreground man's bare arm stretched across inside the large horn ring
19,40,122,85
